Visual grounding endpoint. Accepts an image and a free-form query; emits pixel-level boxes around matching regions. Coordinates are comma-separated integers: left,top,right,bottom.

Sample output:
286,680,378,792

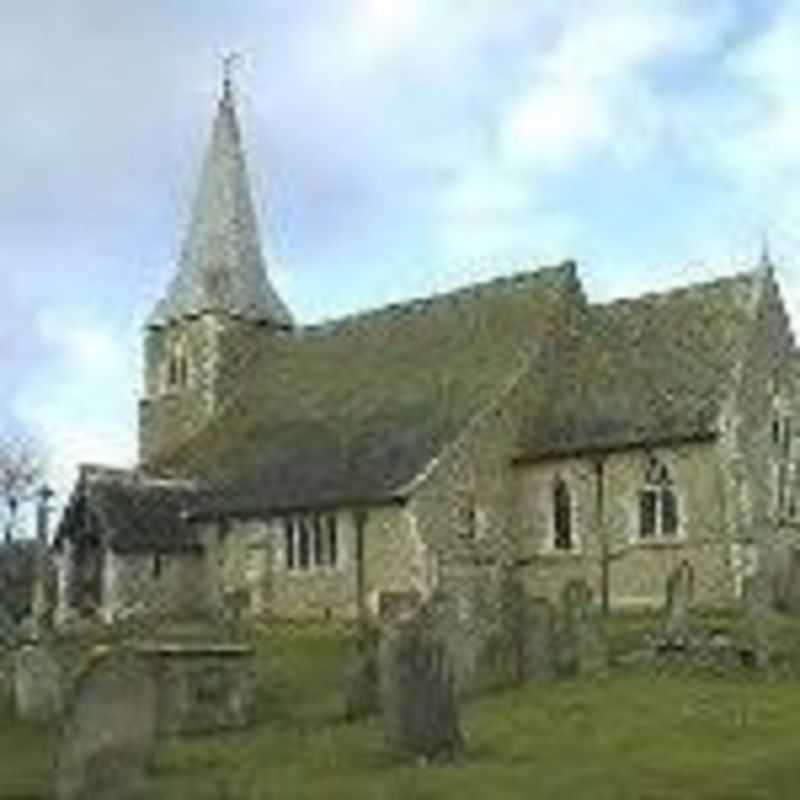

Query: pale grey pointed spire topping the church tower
147,56,292,327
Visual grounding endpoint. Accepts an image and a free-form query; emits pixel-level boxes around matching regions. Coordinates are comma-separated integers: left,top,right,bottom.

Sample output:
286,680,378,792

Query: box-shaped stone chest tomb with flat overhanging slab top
136,642,256,733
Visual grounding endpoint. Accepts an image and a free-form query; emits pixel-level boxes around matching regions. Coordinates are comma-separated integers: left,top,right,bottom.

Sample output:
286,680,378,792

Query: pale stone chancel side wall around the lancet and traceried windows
517,442,735,607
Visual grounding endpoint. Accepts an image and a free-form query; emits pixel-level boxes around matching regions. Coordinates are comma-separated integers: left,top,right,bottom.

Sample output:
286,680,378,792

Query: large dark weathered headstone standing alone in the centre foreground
380,609,463,762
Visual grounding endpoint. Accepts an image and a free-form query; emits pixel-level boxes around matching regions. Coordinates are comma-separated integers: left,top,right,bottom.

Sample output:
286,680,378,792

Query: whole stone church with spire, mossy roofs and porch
55,73,800,622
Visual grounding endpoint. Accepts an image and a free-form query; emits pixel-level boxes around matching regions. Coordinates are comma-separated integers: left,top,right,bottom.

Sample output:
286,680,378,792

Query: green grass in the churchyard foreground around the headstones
0,633,800,800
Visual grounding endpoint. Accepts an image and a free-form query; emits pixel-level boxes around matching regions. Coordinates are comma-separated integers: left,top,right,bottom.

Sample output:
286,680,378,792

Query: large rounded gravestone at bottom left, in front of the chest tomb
55,648,157,800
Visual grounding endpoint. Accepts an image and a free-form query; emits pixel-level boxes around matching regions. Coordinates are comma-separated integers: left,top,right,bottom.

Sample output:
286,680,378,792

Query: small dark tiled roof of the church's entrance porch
55,466,205,553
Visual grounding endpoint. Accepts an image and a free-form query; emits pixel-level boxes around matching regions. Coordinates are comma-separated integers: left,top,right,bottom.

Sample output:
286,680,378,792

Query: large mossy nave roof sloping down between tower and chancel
155,263,583,513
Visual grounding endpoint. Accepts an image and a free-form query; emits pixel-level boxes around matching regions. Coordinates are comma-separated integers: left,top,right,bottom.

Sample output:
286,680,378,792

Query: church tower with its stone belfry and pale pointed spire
139,70,293,464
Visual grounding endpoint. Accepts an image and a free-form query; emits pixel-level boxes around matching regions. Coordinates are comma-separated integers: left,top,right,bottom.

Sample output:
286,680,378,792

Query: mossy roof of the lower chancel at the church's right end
518,269,765,460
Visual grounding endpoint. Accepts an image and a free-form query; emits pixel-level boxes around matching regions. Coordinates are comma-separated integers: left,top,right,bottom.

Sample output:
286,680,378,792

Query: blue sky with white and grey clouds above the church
0,0,800,520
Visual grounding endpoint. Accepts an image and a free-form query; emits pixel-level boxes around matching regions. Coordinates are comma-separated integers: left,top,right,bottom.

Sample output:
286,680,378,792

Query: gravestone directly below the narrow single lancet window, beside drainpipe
556,579,609,677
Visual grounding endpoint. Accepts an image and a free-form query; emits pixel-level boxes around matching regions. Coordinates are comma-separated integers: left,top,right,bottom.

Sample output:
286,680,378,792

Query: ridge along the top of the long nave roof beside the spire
294,260,576,337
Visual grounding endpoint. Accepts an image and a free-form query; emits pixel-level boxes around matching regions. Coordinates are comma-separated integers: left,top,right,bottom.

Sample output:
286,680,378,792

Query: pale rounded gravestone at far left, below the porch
14,642,65,722
